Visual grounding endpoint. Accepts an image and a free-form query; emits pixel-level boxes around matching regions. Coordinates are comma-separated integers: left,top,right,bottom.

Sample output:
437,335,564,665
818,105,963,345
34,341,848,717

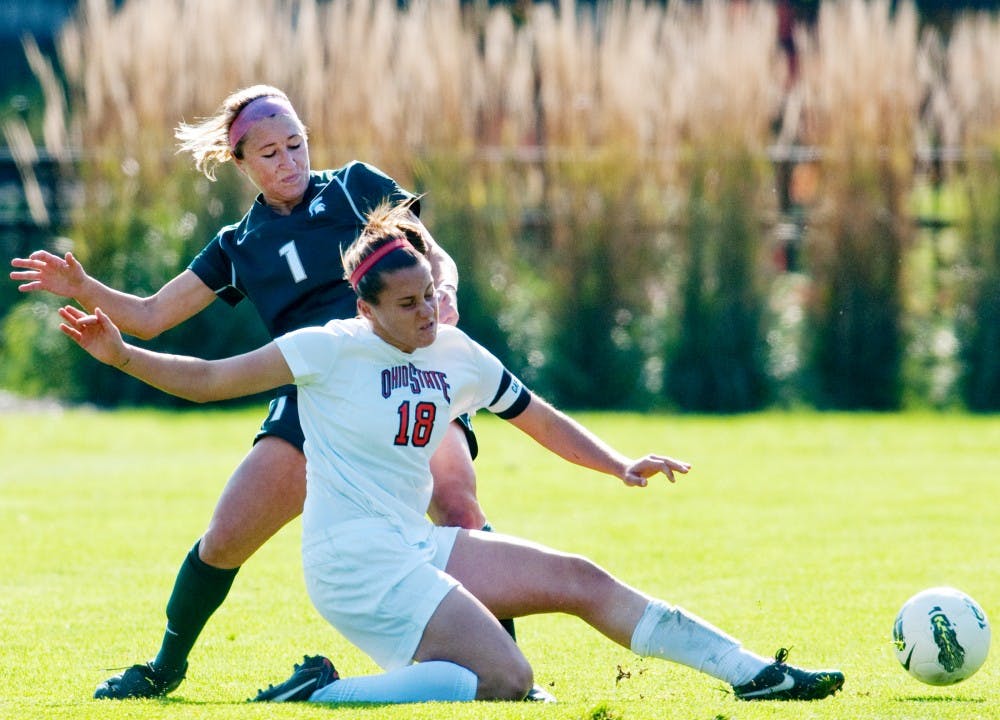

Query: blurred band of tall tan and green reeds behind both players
0,0,1000,412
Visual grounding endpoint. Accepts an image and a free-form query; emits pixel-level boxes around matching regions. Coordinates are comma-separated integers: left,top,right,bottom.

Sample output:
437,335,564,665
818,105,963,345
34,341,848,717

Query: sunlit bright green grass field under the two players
0,409,1000,720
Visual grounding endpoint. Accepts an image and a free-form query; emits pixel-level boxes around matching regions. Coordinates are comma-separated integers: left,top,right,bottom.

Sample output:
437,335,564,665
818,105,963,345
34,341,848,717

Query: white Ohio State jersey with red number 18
276,318,529,544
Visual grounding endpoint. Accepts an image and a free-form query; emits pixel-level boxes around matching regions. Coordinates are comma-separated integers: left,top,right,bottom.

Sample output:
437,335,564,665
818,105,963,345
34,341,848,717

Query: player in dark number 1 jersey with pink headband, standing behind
10,85,541,700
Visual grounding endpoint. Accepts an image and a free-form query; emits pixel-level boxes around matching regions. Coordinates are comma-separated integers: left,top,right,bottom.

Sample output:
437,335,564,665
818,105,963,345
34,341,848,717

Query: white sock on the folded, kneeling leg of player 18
309,660,479,703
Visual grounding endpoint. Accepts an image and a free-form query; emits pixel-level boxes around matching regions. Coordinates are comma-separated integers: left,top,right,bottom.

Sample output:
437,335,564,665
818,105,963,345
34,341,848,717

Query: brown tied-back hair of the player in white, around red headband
342,198,429,305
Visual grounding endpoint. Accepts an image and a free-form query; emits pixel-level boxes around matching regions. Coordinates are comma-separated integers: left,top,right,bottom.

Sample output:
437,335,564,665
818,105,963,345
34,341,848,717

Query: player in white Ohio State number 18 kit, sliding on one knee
60,201,844,703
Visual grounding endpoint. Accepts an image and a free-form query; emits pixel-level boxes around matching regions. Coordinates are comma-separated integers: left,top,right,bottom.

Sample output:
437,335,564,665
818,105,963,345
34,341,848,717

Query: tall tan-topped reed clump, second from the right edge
801,0,922,410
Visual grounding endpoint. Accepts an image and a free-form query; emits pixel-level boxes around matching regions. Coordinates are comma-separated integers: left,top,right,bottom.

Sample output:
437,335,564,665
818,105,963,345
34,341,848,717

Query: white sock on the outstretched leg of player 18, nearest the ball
632,600,772,686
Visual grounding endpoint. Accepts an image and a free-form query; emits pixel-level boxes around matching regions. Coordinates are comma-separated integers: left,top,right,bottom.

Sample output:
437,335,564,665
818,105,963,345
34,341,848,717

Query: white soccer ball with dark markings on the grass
892,587,990,685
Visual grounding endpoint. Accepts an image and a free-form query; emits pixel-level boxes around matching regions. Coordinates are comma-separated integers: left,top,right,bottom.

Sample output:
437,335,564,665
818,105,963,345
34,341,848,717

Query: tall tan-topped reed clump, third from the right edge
652,2,786,412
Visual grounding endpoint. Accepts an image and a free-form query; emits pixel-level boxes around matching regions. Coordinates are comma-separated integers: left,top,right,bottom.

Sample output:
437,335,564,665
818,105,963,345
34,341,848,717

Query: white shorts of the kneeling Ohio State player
302,518,459,670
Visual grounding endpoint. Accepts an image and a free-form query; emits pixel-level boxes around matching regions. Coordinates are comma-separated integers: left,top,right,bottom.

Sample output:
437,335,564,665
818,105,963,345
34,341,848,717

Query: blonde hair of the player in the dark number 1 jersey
174,85,306,180
